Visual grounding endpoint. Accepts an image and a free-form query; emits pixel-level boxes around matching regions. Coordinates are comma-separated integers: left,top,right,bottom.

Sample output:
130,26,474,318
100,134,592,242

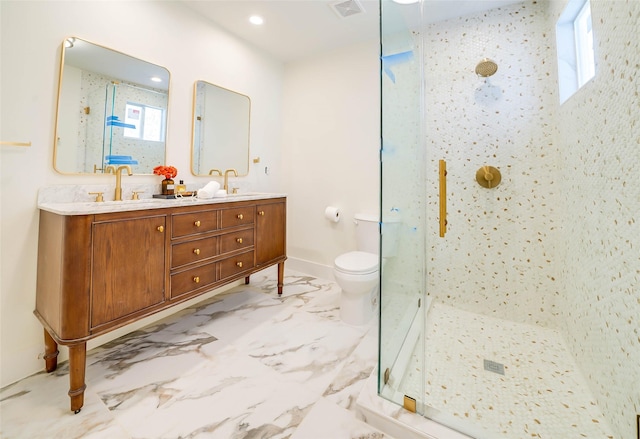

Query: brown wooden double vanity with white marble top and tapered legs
34,194,286,413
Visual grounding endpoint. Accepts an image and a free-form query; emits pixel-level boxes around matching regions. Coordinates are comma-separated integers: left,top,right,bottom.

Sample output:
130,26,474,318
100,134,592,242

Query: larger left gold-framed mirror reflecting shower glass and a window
53,37,170,174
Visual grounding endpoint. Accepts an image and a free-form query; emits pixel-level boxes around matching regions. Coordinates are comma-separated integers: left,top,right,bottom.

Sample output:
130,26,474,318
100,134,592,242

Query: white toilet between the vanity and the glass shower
333,214,380,326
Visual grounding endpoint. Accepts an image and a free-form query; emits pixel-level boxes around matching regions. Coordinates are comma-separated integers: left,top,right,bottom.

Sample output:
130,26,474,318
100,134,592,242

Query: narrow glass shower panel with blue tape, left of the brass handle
378,0,427,413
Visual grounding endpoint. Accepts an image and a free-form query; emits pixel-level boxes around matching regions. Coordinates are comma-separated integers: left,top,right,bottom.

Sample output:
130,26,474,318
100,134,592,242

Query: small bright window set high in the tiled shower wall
556,0,596,103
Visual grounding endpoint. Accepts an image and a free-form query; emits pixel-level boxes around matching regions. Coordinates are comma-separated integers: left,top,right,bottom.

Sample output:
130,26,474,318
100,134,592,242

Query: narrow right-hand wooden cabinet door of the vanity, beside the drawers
255,203,286,266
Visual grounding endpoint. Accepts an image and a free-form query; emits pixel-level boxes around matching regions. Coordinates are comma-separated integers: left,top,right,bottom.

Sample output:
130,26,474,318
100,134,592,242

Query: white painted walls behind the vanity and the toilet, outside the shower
0,0,380,386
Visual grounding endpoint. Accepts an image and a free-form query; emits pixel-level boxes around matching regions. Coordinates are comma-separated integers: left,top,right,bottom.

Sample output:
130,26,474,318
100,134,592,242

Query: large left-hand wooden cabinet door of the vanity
90,216,166,329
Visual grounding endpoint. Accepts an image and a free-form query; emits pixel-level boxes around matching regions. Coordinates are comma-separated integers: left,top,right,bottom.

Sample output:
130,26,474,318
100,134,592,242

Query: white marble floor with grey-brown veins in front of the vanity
0,269,389,439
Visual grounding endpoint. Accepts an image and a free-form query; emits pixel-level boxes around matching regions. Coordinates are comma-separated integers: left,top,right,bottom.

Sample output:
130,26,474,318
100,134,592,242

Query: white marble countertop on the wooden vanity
38,192,286,215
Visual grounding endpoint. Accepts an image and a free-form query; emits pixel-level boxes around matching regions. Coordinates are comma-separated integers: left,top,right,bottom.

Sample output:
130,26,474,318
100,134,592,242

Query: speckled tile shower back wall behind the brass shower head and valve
422,1,560,327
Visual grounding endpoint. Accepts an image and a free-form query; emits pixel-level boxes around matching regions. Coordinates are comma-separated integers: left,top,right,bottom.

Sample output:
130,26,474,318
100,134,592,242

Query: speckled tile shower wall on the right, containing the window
550,0,640,438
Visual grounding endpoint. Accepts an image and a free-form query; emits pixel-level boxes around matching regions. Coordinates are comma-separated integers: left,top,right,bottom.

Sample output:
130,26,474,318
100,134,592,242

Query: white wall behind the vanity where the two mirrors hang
0,0,283,386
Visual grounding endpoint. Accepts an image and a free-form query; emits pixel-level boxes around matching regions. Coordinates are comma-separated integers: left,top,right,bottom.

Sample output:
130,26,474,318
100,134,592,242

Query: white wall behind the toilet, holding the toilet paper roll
282,41,380,277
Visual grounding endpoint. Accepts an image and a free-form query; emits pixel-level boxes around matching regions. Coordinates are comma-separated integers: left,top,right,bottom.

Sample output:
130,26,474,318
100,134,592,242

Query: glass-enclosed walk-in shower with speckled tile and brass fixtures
378,0,640,439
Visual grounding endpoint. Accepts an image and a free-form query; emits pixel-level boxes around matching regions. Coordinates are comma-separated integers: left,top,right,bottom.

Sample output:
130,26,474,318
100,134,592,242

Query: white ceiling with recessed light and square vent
183,0,523,62
